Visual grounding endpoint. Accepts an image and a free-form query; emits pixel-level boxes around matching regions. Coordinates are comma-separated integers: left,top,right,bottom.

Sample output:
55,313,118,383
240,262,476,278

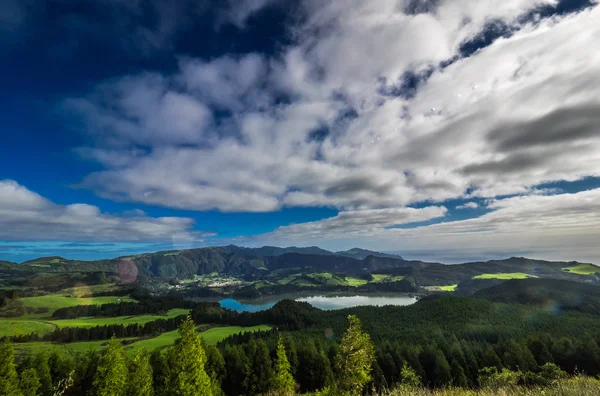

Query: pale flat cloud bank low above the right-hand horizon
246,189,600,263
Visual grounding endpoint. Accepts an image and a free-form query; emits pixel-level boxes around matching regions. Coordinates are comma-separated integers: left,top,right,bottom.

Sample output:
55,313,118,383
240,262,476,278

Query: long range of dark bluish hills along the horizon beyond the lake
0,245,600,295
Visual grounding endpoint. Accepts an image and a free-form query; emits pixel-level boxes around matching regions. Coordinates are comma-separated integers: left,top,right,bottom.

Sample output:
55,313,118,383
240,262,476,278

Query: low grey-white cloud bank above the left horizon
0,180,209,242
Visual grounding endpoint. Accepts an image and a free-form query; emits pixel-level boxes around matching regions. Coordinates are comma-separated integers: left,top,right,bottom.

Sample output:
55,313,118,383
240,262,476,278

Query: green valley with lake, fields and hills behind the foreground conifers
0,246,600,395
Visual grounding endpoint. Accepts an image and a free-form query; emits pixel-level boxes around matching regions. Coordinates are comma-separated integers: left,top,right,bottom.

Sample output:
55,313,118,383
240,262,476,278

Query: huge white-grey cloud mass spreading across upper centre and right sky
65,0,600,217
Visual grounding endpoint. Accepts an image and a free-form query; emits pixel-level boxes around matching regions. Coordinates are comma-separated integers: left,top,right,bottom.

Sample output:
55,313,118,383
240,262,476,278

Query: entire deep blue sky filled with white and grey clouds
0,0,600,263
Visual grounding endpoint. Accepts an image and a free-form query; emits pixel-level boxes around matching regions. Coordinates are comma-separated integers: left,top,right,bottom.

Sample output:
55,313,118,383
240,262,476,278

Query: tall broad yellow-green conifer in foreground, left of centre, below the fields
168,316,212,396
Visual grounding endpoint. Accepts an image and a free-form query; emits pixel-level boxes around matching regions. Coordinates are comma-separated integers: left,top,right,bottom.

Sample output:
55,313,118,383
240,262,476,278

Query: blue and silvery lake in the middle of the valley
219,295,417,312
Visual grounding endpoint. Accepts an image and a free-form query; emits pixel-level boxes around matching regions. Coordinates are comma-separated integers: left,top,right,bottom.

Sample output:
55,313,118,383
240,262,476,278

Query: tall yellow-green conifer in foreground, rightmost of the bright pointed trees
335,315,375,395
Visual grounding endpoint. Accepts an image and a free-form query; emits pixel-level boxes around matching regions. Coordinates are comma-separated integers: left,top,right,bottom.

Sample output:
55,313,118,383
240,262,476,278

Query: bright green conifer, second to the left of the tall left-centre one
94,337,127,396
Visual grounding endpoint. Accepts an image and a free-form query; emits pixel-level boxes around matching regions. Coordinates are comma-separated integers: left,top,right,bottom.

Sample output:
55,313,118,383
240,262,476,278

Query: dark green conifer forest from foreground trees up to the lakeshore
0,280,600,396
